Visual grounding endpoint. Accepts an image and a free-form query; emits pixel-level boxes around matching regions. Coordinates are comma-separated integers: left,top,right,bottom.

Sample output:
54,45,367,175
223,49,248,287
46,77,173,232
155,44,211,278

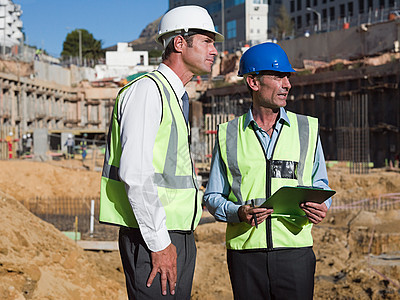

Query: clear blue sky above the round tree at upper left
13,0,169,57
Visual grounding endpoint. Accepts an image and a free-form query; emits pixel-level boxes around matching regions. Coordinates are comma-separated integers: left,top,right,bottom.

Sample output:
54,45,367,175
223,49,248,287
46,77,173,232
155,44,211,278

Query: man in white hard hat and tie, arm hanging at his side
100,6,223,299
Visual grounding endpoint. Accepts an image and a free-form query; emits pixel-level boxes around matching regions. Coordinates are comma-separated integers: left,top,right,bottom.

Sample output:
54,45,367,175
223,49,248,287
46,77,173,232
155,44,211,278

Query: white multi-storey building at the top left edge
0,0,23,55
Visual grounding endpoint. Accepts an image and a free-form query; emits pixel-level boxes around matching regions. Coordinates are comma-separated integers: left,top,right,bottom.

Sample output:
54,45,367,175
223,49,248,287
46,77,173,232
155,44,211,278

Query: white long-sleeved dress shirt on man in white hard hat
119,64,185,252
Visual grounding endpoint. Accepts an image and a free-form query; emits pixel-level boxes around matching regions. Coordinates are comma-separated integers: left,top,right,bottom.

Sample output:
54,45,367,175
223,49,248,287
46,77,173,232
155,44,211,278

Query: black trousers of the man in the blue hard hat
227,247,315,300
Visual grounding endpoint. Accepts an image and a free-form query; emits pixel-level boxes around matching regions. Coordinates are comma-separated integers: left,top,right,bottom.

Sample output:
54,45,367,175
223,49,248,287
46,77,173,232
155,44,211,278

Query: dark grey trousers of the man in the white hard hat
119,227,196,300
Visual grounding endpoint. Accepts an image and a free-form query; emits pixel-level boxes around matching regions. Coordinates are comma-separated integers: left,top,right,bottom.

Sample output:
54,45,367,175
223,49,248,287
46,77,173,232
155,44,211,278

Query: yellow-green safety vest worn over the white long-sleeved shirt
99,71,201,231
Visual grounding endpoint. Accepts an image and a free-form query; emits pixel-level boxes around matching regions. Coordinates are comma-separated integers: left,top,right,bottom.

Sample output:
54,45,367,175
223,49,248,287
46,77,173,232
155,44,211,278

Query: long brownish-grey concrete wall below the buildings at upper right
279,20,400,68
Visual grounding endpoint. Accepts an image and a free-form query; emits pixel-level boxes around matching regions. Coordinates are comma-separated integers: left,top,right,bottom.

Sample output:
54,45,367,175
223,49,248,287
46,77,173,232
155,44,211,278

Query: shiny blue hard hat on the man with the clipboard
238,43,296,76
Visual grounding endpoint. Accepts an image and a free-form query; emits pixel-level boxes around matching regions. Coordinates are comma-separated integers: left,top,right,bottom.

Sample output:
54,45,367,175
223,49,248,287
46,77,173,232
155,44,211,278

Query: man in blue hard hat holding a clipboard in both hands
204,43,332,300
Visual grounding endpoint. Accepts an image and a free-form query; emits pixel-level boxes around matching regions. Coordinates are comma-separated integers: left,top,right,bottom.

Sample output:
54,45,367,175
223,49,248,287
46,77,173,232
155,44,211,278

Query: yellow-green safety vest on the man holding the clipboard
218,112,318,250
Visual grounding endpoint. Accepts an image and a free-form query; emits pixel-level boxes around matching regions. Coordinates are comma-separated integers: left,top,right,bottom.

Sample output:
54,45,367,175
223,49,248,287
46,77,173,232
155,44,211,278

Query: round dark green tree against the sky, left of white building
61,29,104,60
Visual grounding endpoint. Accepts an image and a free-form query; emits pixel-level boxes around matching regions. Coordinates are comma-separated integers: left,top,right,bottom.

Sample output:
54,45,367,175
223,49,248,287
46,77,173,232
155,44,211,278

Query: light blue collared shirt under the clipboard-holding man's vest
204,107,332,223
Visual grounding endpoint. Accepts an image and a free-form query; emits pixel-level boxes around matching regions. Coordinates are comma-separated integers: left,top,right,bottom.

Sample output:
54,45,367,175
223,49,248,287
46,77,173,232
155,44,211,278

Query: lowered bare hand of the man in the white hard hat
147,243,177,296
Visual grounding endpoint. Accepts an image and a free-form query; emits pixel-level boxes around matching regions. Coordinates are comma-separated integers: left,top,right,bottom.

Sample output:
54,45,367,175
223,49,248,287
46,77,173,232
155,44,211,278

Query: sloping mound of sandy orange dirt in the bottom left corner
0,193,126,300
